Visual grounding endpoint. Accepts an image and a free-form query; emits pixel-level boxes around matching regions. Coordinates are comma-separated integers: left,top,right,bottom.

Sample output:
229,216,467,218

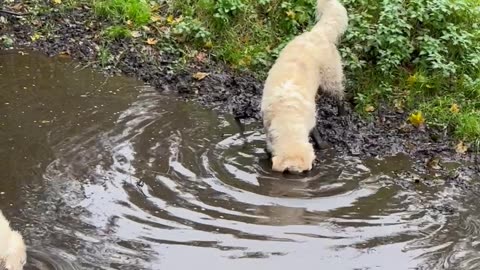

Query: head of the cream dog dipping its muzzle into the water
272,144,315,173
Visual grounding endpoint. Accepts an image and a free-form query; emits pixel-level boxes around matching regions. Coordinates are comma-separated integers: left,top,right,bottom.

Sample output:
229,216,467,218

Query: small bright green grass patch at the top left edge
94,0,152,25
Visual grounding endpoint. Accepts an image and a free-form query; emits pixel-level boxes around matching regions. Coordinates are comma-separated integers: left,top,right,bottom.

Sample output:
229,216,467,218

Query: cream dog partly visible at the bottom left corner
0,211,27,270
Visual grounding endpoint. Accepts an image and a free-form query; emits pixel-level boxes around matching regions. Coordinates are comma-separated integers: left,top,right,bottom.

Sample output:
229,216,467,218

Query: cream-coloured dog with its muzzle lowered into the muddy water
261,0,348,173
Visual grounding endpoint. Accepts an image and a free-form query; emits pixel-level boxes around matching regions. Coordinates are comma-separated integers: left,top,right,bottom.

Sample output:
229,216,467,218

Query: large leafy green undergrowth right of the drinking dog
341,0,480,140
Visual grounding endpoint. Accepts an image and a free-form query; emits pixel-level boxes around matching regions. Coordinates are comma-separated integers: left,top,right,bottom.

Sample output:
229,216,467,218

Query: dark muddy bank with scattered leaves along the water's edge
0,7,478,167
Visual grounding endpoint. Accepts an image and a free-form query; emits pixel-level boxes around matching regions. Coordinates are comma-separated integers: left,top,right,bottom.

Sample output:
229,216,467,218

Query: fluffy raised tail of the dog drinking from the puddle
312,0,348,43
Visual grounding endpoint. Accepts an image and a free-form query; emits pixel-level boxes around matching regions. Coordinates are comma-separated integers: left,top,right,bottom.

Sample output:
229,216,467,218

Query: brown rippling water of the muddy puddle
0,51,480,270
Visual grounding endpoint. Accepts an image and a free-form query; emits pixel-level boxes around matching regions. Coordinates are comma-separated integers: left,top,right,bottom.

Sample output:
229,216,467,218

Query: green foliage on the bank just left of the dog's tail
167,0,316,70
